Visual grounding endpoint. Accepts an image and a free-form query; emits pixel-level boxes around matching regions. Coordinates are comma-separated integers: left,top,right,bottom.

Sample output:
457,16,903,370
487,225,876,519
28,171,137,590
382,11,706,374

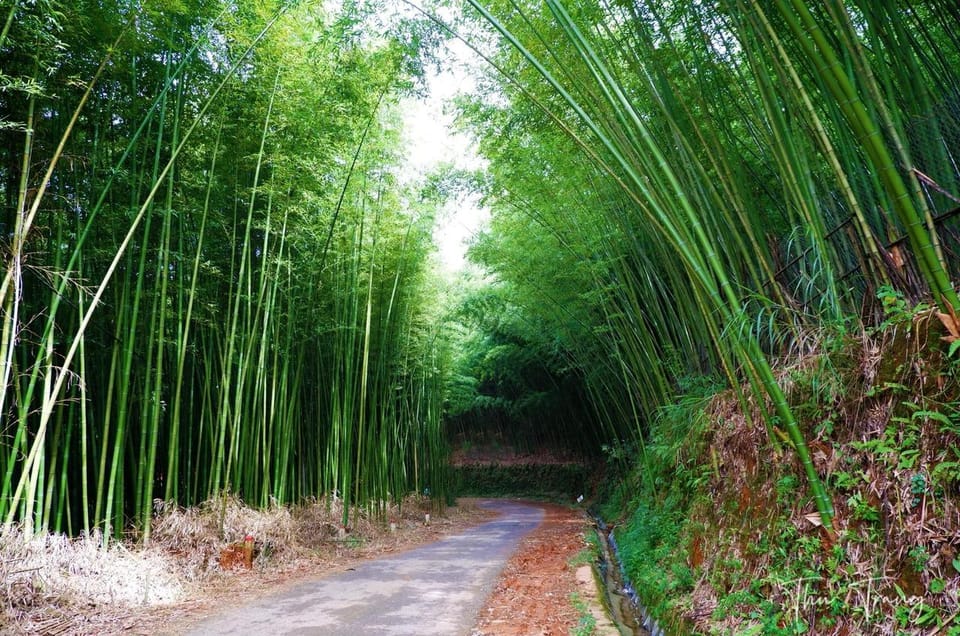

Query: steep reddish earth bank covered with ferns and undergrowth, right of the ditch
602,290,960,636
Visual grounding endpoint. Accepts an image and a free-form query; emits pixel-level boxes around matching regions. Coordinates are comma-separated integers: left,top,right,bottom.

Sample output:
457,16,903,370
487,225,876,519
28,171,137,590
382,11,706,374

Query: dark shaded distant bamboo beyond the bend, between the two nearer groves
445,281,607,457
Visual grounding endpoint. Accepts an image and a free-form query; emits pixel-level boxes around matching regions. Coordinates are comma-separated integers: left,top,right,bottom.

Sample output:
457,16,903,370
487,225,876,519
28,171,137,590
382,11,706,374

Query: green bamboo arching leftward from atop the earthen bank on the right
460,0,960,528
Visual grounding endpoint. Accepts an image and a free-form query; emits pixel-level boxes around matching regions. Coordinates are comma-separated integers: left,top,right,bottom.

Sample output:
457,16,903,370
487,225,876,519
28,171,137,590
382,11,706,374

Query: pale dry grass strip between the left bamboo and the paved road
0,496,484,634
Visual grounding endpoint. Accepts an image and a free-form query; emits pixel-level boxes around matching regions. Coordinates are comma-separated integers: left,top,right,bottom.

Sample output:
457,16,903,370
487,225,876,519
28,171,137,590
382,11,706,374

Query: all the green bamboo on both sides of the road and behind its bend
0,0,960,539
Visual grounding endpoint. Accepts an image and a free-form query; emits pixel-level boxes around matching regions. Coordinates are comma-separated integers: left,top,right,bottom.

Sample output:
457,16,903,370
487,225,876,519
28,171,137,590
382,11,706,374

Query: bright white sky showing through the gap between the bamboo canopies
401,40,489,271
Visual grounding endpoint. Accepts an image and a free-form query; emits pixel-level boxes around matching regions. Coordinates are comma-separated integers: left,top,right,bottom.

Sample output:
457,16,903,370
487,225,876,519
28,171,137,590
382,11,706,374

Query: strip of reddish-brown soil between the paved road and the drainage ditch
473,503,588,636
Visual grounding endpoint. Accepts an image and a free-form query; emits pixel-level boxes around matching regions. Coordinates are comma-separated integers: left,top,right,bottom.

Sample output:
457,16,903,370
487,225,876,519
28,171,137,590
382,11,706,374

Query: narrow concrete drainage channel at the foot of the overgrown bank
594,517,664,636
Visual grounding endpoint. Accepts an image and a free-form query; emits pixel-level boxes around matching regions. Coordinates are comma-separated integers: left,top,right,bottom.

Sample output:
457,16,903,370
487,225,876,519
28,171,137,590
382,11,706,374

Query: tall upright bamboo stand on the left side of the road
0,0,445,540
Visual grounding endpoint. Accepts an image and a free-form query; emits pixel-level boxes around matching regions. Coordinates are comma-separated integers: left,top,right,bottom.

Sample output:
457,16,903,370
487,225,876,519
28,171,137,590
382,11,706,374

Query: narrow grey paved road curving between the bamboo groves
184,501,543,636
